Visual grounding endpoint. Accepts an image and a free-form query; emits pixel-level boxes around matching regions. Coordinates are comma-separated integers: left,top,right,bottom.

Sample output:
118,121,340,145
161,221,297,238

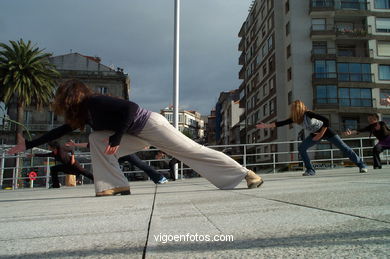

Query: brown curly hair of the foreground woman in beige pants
53,79,94,130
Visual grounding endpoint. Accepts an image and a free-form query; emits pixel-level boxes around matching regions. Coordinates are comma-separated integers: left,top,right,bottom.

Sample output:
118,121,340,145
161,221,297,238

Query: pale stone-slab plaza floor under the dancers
0,168,390,259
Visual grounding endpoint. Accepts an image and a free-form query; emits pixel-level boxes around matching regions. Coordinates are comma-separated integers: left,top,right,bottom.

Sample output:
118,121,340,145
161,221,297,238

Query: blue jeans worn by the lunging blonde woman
298,135,366,172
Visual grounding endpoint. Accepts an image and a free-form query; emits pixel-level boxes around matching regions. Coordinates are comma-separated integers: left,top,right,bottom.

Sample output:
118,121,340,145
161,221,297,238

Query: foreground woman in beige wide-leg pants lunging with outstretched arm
8,80,263,196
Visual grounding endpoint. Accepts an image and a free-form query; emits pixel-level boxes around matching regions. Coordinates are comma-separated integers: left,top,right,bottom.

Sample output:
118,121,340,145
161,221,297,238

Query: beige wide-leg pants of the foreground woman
89,112,249,192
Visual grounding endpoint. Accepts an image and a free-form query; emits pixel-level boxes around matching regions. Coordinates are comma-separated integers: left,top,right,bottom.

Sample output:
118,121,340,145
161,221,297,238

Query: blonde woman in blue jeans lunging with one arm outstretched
256,100,367,176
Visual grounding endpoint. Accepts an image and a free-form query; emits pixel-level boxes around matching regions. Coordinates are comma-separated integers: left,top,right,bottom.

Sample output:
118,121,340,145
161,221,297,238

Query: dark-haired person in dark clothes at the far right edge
344,113,390,169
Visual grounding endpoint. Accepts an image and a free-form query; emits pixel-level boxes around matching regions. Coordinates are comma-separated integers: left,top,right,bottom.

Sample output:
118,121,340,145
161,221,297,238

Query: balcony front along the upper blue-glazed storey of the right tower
312,72,374,83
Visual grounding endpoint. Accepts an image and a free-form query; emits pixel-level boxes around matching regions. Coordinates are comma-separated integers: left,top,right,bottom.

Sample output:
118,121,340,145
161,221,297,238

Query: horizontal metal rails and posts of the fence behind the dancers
0,137,384,189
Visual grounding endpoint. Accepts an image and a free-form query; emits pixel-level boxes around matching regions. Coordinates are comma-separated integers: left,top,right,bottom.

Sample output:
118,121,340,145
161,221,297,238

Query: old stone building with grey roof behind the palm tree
0,53,130,144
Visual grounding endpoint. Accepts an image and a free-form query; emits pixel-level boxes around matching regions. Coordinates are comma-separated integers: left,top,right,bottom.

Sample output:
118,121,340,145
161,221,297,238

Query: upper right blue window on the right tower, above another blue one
337,63,372,82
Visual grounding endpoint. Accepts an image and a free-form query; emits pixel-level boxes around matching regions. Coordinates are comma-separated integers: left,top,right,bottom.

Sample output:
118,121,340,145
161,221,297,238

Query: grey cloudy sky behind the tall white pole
0,0,252,115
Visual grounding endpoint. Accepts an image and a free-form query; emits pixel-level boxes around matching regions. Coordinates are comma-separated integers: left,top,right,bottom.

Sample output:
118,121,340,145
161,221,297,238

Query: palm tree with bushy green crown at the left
0,39,59,140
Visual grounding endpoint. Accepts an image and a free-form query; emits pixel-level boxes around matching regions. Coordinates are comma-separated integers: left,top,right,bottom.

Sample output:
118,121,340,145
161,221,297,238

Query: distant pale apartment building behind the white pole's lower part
160,105,205,142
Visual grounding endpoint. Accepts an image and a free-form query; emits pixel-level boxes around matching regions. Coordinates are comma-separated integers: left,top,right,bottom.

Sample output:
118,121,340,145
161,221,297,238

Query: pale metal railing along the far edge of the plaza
0,137,389,189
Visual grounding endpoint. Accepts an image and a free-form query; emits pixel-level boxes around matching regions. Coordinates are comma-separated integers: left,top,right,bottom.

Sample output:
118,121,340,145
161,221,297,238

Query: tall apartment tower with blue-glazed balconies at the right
238,0,390,166
